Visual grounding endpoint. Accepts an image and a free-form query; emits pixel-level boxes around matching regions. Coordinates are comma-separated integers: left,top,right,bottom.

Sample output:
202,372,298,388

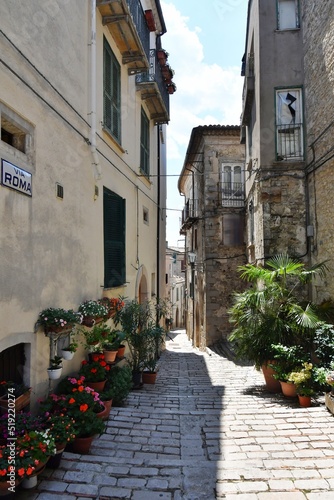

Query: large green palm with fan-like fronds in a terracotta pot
229,254,327,368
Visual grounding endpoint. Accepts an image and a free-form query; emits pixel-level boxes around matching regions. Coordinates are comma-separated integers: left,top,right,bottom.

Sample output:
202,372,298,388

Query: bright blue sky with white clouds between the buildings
161,0,248,247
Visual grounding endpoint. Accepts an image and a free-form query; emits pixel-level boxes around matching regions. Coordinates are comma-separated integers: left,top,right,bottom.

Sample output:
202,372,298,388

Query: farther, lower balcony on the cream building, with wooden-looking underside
136,49,169,123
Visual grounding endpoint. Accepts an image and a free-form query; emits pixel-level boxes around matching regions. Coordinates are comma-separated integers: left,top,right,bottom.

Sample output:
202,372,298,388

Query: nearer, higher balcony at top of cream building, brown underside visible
97,0,150,74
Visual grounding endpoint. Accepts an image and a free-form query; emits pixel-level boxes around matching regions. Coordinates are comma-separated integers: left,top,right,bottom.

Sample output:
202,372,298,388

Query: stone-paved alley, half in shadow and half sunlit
16,330,334,500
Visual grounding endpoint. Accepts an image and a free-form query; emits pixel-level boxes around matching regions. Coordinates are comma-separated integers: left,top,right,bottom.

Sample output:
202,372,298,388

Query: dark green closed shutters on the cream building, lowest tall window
103,187,125,288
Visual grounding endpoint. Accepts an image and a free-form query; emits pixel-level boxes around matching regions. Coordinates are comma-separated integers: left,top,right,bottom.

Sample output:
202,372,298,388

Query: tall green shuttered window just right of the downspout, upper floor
103,39,121,142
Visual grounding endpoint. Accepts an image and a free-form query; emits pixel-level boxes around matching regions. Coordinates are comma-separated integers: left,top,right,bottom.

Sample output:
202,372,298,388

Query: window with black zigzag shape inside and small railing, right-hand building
276,88,304,160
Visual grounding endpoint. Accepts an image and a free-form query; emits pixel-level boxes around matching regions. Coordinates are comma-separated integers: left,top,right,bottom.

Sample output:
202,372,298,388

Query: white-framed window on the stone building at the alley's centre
221,164,244,206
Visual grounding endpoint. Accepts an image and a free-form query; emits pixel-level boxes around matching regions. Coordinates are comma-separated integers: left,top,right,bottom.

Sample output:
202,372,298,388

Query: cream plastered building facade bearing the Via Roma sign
0,0,169,398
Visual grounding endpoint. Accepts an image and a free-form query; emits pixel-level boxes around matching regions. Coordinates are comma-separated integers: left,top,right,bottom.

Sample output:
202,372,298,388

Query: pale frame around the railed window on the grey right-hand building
275,85,305,161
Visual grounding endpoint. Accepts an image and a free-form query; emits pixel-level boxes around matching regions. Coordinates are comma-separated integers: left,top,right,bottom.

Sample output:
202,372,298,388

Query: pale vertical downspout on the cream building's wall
89,0,101,180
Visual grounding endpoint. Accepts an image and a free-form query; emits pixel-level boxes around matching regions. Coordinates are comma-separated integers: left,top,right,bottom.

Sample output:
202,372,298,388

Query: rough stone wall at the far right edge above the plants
301,0,334,302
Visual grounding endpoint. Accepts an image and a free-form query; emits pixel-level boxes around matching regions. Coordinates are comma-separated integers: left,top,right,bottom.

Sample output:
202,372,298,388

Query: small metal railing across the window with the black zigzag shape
276,123,303,160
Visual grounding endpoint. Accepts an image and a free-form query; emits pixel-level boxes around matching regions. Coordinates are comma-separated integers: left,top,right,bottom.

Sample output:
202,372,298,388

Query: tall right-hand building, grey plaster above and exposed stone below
241,0,307,262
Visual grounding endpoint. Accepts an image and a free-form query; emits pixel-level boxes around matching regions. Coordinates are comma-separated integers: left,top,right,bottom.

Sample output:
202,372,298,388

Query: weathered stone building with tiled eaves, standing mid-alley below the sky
178,125,246,349
